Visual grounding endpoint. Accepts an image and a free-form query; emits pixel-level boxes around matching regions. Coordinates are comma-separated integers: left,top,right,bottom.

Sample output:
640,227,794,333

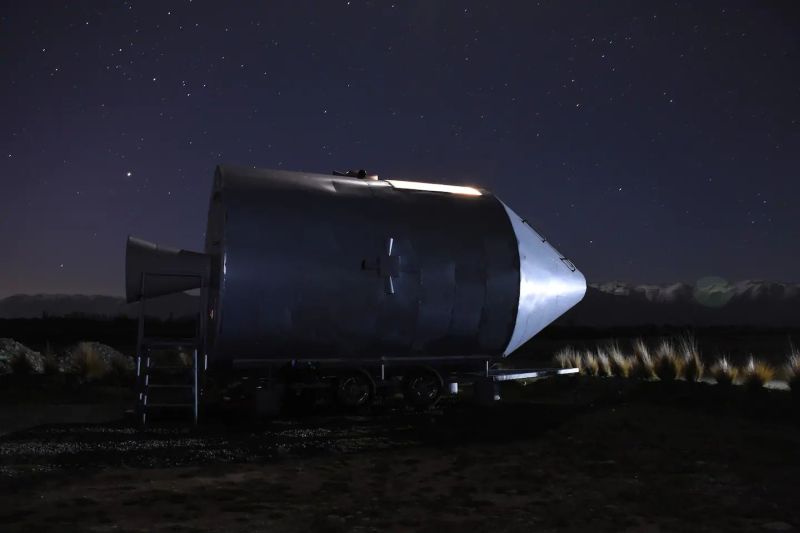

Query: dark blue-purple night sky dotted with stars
0,0,800,297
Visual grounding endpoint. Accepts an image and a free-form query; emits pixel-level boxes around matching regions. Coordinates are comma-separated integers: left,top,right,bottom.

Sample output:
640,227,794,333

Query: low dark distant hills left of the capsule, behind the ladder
0,293,198,319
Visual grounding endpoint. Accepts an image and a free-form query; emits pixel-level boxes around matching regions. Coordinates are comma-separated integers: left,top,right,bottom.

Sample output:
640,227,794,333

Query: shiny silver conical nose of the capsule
501,202,586,355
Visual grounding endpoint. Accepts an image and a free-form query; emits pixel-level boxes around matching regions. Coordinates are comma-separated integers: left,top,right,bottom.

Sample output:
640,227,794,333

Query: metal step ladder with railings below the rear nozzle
136,274,208,428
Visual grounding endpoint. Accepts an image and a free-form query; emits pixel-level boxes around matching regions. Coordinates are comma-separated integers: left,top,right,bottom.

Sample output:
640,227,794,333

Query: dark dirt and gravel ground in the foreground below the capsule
0,378,800,533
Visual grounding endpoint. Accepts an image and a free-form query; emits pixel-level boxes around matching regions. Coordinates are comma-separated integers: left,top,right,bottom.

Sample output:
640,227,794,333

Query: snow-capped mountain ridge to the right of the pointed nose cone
556,280,800,328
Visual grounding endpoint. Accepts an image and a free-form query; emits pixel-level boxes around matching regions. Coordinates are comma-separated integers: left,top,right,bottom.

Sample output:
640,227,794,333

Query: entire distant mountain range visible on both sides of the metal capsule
0,278,800,328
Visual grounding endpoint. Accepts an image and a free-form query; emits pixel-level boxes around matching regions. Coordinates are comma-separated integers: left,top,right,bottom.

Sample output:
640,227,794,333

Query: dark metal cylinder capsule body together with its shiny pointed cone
198,166,586,362
